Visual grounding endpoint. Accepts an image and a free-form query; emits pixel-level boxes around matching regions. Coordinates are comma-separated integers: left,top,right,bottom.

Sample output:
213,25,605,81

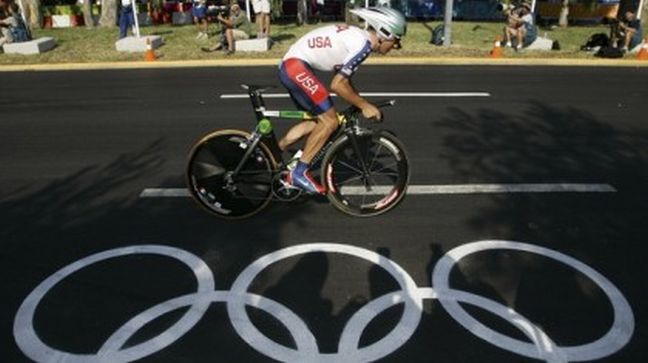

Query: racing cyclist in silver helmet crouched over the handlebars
279,7,407,194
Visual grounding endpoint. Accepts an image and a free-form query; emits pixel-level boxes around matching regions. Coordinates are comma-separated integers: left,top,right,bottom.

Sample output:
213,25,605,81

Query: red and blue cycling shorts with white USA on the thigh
279,58,333,116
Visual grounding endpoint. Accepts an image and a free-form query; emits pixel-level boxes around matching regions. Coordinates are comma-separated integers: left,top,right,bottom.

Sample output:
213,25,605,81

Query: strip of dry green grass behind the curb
0,21,624,65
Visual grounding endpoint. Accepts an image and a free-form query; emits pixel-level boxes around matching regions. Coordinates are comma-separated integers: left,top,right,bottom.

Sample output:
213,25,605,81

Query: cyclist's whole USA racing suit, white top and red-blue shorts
279,24,371,115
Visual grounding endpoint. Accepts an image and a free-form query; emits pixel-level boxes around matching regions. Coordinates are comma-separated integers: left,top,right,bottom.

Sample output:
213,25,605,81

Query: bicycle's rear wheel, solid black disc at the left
187,130,276,219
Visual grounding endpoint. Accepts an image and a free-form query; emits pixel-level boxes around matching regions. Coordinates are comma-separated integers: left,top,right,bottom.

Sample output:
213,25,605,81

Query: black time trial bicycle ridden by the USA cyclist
186,85,409,219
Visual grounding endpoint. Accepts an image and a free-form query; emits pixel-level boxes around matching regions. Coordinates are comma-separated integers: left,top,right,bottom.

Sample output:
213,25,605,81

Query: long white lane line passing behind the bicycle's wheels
140,183,617,198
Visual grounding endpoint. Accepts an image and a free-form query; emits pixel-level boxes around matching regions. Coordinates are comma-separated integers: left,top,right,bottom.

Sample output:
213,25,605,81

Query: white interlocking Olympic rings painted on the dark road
14,240,635,363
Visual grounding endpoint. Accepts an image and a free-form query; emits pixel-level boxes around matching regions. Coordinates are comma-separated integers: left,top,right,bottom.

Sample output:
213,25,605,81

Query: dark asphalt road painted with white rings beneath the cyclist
0,66,648,362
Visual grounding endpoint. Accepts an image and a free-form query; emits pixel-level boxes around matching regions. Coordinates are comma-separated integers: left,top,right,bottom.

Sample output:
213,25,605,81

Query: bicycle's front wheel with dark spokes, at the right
322,131,409,217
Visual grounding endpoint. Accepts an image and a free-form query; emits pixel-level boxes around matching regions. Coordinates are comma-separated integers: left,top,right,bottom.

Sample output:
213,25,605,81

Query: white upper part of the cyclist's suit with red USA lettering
283,24,371,77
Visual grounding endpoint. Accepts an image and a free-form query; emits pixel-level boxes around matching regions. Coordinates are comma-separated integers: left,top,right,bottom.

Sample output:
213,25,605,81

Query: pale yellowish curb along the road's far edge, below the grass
0,57,648,72
